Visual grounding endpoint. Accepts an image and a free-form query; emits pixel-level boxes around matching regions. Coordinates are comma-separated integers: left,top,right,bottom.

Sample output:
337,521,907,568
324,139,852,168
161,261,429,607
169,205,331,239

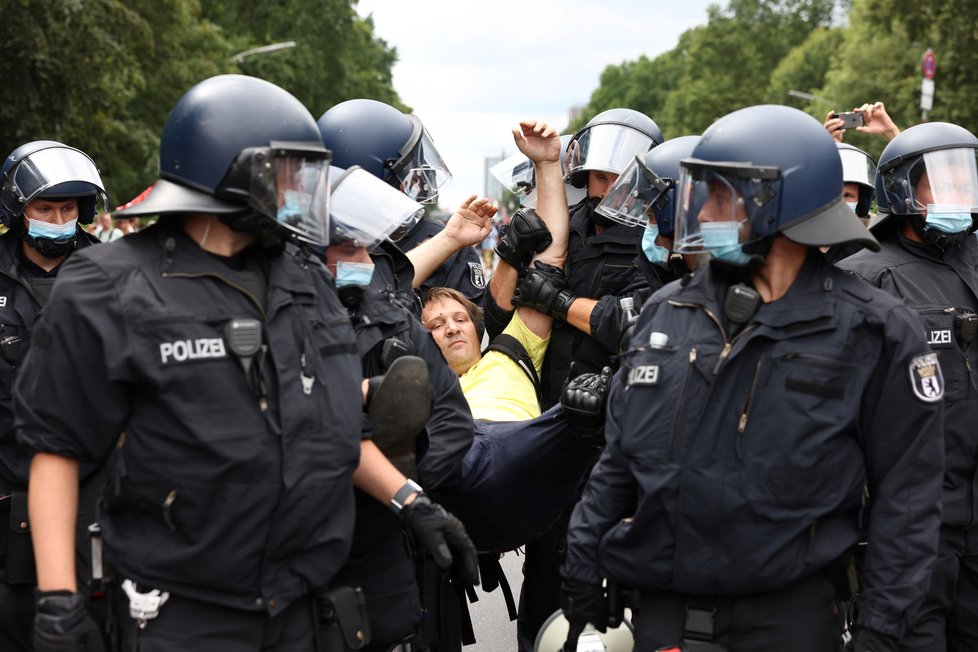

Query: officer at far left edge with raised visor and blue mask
0,140,106,651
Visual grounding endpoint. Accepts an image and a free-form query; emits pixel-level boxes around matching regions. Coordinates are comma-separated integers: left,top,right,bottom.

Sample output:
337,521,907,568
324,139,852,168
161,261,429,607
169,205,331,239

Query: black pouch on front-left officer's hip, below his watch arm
313,586,370,652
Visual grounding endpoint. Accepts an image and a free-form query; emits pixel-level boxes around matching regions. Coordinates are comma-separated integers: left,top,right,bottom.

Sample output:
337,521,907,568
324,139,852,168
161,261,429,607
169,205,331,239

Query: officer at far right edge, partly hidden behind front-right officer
840,122,978,650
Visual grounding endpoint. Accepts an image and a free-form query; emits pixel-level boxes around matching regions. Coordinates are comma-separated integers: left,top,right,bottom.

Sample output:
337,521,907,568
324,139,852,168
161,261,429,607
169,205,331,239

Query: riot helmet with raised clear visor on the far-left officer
0,147,106,215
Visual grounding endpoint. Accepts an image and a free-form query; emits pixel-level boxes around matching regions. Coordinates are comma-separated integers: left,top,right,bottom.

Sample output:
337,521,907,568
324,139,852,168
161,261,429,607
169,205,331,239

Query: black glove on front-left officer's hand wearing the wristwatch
401,494,479,586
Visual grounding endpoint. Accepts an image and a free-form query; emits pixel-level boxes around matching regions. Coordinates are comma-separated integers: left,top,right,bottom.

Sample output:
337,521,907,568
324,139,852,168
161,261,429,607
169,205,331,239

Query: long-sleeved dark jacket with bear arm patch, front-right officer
565,251,943,635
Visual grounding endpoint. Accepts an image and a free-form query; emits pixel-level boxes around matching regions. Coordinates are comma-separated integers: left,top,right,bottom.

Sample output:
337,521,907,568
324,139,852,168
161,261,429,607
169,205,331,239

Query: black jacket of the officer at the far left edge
0,230,98,493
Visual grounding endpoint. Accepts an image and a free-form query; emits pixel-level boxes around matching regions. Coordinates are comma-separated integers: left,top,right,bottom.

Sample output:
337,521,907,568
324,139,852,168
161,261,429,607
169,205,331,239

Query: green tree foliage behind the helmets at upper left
0,0,403,204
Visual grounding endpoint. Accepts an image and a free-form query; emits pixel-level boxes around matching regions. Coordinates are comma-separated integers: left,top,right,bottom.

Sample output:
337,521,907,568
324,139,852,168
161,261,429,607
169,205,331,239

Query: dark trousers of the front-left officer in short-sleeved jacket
116,589,315,652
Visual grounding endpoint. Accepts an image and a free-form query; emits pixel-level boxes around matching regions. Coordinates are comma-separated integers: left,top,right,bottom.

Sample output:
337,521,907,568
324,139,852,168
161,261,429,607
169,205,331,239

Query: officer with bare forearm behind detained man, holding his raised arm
483,109,663,650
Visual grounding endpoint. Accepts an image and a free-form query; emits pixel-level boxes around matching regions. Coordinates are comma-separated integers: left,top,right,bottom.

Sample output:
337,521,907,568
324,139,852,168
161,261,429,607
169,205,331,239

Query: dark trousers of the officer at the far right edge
900,525,978,652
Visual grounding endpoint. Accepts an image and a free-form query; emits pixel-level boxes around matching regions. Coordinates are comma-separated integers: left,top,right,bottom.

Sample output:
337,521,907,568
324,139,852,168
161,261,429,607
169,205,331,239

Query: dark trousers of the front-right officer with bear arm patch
632,575,842,652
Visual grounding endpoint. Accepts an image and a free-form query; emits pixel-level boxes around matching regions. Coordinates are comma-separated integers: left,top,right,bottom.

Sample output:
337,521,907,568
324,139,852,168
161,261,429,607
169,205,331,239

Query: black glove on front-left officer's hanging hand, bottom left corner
34,591,105,652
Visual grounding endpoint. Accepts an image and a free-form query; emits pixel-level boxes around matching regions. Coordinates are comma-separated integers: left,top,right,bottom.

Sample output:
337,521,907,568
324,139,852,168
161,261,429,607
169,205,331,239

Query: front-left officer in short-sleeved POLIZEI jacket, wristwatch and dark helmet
15,75,470,651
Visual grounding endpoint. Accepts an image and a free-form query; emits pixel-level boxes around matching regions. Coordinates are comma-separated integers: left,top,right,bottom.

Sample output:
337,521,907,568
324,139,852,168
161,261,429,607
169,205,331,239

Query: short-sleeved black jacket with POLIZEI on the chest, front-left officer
15,224,362,614
